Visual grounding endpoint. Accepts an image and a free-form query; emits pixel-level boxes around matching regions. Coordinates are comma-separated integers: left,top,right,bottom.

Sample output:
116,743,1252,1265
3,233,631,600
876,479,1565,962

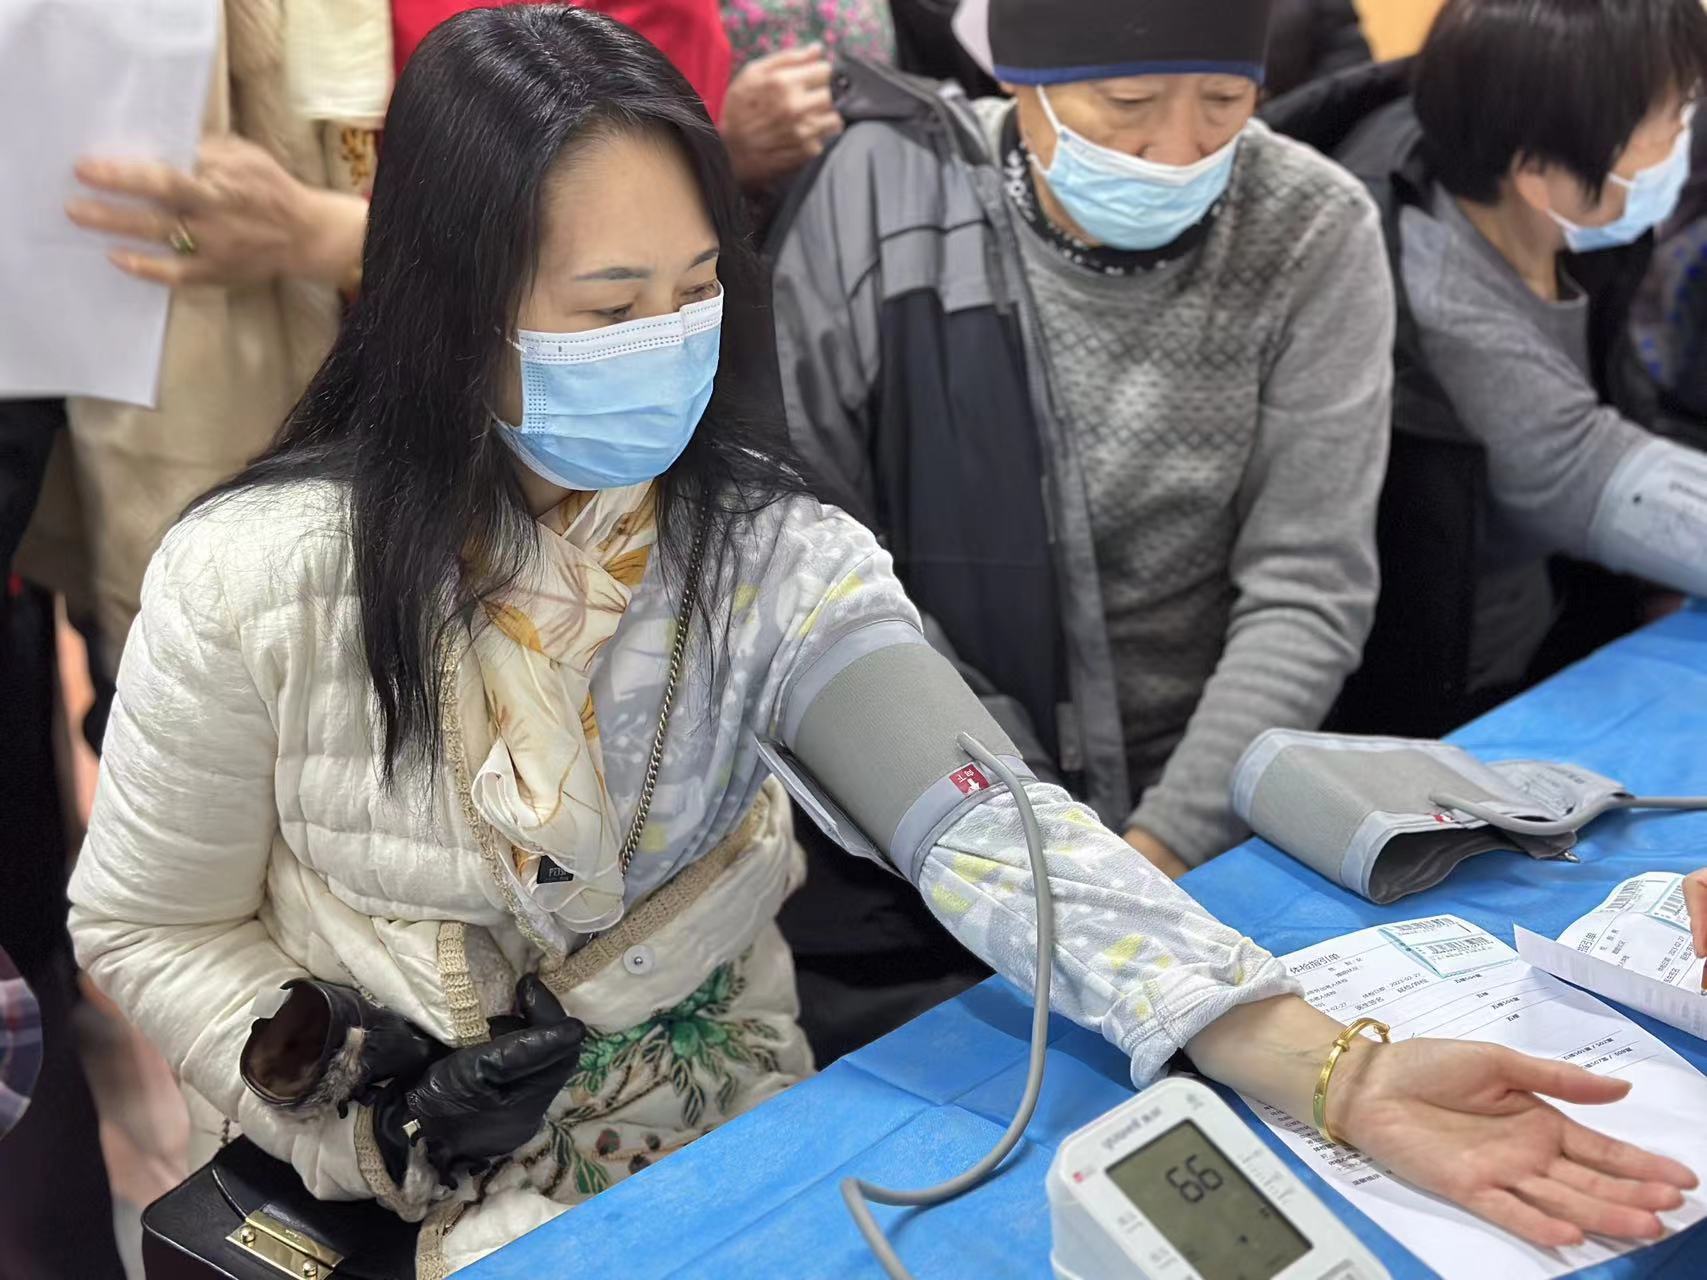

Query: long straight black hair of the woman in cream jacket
201,5,806,782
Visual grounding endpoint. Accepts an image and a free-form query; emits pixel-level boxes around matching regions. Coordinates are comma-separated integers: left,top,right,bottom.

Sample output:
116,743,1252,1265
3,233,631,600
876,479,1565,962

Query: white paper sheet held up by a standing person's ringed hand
0,0,218,406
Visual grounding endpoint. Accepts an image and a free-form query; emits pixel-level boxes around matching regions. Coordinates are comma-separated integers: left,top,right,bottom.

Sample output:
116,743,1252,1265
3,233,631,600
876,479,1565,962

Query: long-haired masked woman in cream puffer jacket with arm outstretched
72,5,1693,1275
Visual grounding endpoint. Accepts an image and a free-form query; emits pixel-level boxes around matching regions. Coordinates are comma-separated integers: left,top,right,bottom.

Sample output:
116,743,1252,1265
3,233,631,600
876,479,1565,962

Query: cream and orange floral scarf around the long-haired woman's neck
471,485,657,934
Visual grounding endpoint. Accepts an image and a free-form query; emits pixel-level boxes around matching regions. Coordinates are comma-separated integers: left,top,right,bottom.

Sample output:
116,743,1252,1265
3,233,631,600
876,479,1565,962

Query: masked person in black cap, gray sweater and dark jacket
773,0,1393,1058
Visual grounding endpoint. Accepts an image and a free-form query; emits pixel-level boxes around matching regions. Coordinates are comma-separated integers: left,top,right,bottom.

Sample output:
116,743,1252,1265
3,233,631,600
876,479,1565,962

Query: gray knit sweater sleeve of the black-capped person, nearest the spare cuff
1132,180,1395,865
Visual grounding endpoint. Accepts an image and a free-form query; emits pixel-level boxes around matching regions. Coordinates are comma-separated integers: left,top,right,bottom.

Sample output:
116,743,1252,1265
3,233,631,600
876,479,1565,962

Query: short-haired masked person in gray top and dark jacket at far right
1268,0,1707,736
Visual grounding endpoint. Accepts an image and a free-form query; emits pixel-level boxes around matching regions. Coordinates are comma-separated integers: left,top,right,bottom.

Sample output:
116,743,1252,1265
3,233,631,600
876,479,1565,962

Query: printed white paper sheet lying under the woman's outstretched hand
1246,916,1707,1280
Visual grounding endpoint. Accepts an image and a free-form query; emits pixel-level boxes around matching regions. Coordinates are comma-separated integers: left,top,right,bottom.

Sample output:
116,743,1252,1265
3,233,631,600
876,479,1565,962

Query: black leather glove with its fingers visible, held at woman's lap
374,975,587,1186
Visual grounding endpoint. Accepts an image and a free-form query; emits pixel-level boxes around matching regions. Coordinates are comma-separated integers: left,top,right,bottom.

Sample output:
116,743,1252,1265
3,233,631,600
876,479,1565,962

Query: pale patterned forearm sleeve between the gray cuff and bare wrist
918,783,1301,1087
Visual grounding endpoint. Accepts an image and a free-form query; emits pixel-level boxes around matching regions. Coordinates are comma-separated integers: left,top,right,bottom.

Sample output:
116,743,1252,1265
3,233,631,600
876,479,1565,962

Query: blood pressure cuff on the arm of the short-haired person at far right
1589,439,1707,596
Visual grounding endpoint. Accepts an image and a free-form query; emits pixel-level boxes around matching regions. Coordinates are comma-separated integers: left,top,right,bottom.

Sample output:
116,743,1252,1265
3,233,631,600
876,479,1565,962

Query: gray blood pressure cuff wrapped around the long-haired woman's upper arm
760,621,1033,884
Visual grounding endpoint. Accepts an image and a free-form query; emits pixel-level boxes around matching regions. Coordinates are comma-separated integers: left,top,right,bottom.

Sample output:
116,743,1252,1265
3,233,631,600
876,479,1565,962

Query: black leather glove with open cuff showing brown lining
239,980,451,1116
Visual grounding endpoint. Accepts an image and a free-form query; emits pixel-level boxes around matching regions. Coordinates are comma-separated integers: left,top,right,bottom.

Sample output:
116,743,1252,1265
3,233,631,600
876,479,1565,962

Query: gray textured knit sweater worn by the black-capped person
983,108,1393,865
